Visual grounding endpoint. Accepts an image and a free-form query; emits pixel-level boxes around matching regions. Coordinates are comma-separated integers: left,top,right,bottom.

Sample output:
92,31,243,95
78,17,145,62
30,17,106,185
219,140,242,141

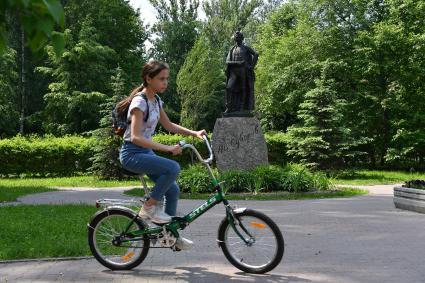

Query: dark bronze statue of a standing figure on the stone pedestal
223,30,258,116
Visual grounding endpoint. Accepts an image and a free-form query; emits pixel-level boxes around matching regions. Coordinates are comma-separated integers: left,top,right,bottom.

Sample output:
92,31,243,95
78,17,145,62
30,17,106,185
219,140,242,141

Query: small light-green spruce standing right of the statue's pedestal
288,61,357,170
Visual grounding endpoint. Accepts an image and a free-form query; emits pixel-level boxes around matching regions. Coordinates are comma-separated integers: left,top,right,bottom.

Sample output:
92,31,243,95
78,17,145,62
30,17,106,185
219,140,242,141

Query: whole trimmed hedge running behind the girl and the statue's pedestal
0,133,287,176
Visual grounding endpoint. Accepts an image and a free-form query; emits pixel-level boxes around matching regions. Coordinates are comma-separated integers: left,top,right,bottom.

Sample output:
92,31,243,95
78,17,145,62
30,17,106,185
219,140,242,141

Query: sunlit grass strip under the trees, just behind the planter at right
333,170,425,185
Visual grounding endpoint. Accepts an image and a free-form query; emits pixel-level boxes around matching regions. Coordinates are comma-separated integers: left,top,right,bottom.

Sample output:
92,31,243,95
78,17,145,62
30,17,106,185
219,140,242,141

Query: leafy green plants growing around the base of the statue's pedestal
178,164,332,194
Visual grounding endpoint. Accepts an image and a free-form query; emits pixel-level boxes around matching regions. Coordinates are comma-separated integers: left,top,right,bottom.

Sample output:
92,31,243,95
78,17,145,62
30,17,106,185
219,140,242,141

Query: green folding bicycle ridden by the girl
88,136,284,273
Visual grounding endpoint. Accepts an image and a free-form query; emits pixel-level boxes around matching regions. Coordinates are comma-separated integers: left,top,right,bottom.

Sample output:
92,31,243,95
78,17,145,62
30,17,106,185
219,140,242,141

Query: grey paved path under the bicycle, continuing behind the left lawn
0,186,425,283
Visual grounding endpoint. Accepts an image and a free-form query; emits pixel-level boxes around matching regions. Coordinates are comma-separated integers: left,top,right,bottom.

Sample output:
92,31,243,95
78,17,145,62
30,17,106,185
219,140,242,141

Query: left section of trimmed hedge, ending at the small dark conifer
0,136,94,176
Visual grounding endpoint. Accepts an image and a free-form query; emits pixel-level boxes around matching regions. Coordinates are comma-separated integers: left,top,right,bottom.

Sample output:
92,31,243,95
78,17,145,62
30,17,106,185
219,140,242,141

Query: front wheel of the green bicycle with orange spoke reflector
218,209,284,274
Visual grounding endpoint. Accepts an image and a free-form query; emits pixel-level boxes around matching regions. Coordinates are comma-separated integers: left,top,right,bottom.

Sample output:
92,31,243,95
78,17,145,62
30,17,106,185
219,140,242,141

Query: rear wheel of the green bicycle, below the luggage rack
88,209,150,270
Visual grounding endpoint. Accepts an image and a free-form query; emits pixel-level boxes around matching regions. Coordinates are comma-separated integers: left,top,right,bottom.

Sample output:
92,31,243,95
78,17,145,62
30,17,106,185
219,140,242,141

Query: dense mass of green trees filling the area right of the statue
255,0,425,169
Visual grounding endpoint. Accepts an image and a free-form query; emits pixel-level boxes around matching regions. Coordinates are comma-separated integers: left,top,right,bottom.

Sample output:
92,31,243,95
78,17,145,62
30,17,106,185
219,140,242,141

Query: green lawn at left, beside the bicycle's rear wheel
0,205,97,260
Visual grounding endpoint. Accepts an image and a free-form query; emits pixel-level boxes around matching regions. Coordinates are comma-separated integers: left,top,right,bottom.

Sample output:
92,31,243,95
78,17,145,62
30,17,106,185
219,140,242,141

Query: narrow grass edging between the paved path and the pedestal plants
124,188,368,200
